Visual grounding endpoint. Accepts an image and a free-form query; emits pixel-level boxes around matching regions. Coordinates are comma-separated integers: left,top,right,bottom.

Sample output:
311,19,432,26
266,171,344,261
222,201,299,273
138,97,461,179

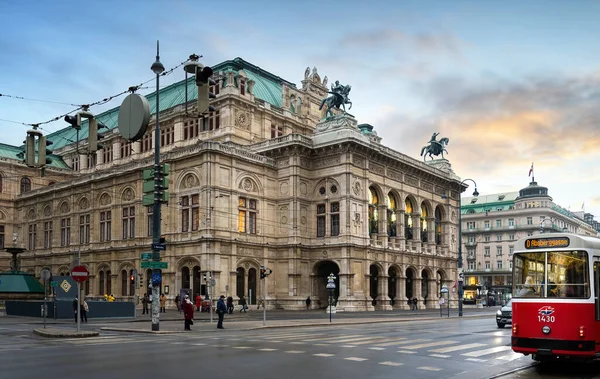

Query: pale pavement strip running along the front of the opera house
11,307,498,338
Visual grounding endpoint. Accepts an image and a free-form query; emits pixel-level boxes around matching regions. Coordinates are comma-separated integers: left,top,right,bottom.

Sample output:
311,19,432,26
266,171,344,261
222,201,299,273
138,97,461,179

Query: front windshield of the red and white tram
513,251,590,299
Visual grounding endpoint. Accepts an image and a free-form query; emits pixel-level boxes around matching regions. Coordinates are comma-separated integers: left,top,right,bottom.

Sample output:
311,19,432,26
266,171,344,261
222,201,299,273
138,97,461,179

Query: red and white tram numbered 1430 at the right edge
511,233,600,361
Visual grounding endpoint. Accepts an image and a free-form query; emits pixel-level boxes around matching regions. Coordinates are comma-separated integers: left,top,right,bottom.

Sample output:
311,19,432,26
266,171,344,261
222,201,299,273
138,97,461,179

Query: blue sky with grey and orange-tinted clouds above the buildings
0,0,600,219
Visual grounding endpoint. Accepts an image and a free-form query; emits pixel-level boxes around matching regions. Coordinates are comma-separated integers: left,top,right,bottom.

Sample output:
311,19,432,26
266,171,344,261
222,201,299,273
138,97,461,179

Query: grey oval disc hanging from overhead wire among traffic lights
119,93,150,141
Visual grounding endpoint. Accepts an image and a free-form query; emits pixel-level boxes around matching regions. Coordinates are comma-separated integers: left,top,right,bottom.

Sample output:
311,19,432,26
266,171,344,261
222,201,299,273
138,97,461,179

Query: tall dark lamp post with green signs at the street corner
150,41,165,331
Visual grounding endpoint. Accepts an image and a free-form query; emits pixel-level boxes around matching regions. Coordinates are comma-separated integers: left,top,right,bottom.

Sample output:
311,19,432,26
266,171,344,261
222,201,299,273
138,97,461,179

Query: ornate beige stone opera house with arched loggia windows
0,58,465,311
